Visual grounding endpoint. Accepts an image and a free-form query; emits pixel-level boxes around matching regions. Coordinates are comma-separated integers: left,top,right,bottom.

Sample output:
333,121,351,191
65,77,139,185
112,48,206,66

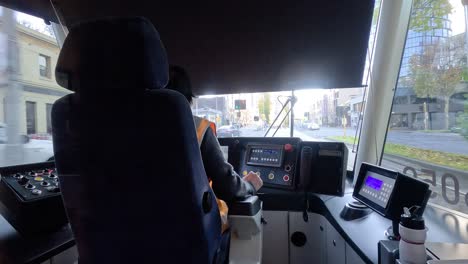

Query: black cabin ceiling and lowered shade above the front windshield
0,0,374,95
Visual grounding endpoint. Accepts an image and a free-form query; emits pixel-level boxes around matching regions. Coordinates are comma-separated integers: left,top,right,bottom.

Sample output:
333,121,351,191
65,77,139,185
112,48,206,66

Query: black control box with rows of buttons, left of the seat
0,162,68,234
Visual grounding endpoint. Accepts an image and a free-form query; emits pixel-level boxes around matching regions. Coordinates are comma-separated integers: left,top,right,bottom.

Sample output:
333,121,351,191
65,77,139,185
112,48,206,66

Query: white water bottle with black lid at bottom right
398,206,427,264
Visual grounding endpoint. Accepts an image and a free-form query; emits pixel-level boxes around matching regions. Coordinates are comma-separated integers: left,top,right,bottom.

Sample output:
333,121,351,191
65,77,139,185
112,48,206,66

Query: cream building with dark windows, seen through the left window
0,20,70,135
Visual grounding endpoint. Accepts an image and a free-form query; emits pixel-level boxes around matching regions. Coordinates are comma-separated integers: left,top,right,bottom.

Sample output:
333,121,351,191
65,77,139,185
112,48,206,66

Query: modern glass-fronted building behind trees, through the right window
390,3,468,130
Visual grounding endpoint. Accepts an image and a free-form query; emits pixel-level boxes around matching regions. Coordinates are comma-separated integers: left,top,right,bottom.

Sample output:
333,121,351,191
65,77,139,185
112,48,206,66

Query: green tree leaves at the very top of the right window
410,0,453,32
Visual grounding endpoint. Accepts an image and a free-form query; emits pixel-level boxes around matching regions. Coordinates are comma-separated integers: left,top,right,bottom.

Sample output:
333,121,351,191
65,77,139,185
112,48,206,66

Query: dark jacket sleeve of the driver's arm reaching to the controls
200,126,255,205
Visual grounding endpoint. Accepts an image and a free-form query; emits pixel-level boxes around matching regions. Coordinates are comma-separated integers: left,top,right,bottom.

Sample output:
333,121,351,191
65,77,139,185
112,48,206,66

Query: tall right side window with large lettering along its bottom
382,0,468,213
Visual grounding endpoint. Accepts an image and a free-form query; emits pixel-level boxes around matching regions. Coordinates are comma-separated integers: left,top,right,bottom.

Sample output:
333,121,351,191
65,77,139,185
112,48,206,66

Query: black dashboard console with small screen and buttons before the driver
219,137,348,196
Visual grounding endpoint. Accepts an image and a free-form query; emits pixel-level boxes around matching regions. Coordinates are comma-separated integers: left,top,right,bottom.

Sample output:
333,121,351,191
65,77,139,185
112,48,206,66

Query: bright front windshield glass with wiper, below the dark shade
192,88,364,170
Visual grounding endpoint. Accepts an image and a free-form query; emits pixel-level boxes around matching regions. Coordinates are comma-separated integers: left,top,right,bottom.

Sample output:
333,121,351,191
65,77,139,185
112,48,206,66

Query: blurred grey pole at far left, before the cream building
2,8,23,165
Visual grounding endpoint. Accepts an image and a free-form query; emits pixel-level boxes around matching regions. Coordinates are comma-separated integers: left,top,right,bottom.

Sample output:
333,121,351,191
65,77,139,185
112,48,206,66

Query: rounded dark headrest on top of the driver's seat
55,17,169,93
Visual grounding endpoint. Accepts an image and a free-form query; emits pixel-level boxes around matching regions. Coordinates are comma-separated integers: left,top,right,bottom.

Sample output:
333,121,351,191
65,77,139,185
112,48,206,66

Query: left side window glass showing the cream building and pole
0,8,64,166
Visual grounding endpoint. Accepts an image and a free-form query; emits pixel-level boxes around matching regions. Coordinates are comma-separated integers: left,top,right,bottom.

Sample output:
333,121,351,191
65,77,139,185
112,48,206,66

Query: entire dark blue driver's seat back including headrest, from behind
52,18,220,263
